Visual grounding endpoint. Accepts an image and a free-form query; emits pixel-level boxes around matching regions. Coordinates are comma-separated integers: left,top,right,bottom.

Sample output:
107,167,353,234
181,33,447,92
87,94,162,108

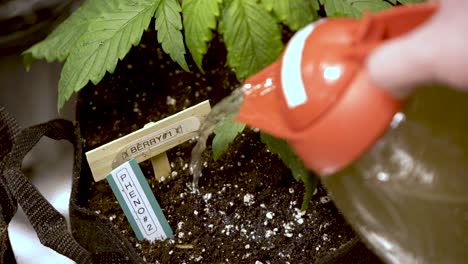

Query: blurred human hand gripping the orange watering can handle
367,0,468,98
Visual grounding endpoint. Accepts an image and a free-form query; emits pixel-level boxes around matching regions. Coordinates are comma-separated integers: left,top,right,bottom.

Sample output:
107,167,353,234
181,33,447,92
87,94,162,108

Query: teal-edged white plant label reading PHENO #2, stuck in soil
106,159,173,241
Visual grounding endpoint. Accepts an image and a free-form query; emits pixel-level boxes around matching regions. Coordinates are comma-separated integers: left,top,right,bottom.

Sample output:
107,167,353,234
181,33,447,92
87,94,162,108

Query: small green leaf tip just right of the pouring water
211,115,245,160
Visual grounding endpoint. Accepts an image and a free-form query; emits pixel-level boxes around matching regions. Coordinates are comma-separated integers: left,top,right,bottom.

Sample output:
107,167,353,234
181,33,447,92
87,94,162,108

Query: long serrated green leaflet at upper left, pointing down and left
58,0,155,109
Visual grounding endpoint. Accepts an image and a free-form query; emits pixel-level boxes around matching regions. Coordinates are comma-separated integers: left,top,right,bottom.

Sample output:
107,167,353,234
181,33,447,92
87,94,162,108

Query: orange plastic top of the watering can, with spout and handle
237,3,437,174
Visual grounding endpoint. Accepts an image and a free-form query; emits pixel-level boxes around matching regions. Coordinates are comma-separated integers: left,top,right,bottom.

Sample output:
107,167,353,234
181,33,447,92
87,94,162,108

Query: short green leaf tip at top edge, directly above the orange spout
262,0,318,31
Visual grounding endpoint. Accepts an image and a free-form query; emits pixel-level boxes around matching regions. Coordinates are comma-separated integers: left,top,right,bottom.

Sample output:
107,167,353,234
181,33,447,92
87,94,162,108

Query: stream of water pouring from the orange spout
189,88,243,192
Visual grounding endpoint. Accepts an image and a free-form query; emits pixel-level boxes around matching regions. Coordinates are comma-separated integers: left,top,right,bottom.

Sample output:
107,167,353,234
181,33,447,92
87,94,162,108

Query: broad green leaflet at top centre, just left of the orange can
220,0,283,79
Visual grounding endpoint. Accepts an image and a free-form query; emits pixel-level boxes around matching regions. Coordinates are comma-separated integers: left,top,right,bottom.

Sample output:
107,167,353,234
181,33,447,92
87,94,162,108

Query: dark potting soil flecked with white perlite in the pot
77,25,379,263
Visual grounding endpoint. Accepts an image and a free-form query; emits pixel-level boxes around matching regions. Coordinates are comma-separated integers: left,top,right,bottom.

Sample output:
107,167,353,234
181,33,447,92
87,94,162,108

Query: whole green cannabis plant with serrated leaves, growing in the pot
23,0,420,208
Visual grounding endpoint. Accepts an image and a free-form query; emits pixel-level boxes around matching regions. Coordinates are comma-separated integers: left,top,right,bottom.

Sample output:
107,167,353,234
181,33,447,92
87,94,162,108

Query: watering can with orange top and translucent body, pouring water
237,4,468,263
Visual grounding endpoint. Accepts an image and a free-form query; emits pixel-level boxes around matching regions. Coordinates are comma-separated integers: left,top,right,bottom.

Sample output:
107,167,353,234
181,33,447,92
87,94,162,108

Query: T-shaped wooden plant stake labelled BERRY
86,101,211,181
